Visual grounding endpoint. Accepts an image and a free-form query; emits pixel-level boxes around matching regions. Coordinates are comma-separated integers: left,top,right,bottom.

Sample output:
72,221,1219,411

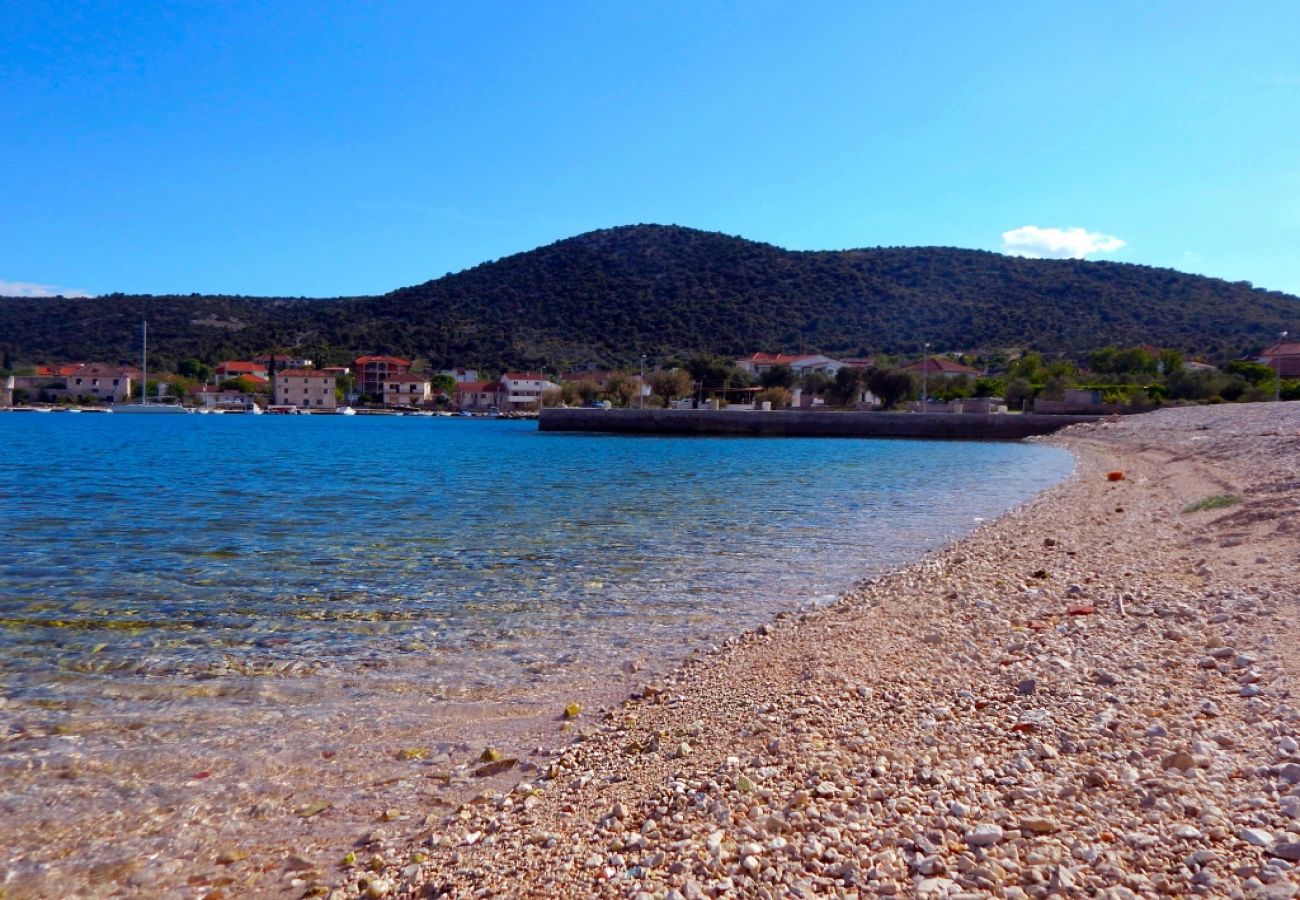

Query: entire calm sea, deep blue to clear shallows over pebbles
0,414,1073,897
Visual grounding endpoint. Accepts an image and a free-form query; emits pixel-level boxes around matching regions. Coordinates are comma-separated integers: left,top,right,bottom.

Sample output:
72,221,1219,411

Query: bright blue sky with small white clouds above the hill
0,0,1300,297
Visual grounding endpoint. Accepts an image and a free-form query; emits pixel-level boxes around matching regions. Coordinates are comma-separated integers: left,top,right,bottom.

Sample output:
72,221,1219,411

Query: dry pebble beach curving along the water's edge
322,403,1300,899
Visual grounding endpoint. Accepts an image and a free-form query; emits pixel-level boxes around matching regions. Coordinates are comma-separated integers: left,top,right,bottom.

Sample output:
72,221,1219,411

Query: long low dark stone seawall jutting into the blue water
538,410,1100,441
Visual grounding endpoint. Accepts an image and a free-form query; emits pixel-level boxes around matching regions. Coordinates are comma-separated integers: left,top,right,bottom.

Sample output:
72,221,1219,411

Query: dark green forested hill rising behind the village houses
0,225,1300,369
